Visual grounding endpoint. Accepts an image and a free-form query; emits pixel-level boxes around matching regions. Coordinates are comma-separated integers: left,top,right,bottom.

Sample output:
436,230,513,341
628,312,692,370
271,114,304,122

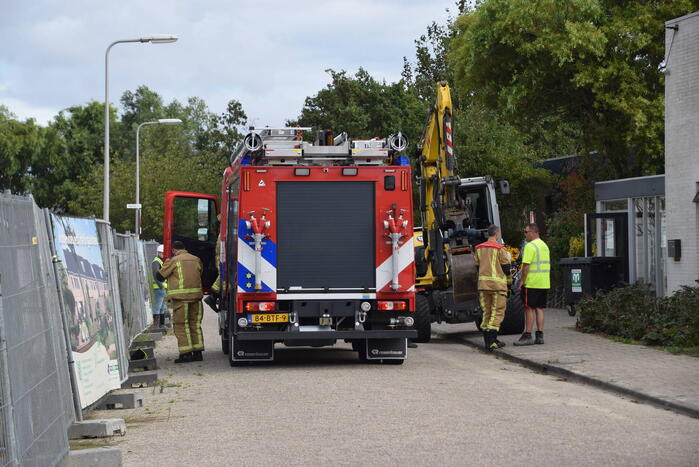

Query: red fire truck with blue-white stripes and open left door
164,128,416,366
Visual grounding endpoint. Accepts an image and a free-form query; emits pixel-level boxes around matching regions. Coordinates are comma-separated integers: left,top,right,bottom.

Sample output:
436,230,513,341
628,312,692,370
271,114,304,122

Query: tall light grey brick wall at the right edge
665,12,699,293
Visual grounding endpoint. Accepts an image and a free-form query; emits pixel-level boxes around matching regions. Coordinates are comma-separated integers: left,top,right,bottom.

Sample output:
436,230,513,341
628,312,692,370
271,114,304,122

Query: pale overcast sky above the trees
0,0,454,126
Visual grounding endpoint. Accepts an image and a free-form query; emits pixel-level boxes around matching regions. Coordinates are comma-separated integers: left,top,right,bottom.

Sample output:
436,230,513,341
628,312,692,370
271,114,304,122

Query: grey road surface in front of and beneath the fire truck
108,310,699,466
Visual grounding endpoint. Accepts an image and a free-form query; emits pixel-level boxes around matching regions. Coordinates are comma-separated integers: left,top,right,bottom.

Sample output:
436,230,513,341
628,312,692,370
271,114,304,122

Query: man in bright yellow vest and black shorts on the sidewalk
515,224,551,345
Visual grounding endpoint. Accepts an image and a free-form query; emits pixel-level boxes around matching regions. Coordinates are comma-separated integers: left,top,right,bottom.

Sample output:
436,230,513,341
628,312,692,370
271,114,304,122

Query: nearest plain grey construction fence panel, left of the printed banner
0,195,75,466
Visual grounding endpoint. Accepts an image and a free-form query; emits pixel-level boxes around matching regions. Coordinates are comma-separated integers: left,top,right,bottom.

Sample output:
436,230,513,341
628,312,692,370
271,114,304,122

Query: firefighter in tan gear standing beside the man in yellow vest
475,225,511,350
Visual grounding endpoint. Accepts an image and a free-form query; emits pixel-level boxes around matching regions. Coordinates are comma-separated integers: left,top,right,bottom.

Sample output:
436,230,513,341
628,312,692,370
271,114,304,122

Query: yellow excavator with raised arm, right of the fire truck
413,81,524,342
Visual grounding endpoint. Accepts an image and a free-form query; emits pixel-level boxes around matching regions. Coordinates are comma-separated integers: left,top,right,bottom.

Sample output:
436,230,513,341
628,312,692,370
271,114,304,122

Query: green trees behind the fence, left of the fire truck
0,86,246,239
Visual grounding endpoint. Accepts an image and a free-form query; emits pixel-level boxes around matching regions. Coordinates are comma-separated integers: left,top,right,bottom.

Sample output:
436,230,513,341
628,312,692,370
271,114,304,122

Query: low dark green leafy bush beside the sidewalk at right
577,283,699,347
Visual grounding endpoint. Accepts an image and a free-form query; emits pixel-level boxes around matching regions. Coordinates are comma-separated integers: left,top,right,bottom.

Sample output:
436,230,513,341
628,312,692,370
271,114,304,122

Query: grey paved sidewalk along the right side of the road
432,309,699,418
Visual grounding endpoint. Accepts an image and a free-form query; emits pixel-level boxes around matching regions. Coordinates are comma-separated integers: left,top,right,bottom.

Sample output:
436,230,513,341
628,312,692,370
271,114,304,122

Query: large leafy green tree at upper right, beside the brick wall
450,0,697,177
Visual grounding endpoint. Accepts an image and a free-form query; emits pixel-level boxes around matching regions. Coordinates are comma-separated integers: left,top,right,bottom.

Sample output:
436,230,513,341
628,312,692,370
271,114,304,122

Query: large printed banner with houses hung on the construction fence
51,215,121,408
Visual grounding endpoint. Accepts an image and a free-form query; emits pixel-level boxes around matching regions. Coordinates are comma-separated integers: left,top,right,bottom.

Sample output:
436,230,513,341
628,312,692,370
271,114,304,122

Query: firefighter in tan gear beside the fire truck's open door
156,240,204,363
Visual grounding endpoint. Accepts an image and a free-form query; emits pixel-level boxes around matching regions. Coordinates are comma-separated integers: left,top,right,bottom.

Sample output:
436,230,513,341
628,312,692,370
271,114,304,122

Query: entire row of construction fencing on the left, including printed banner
0,193,157,467
